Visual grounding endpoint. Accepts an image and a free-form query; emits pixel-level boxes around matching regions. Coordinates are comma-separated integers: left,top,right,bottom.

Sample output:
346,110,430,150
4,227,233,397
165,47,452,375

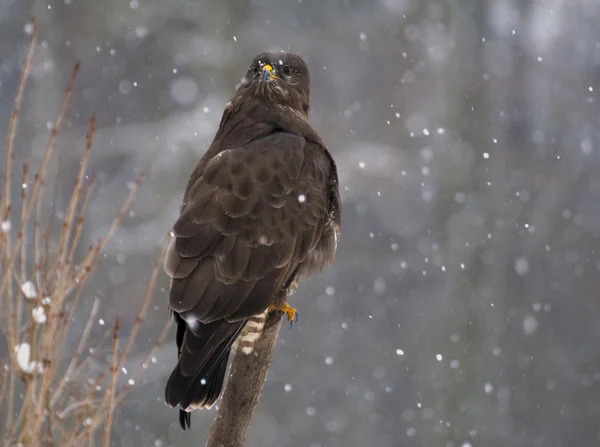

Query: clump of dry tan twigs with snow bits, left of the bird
0,17,168,447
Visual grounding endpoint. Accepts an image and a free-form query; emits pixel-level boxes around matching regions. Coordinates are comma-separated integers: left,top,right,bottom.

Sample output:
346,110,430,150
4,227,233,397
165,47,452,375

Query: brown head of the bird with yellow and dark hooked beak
240,52,310,118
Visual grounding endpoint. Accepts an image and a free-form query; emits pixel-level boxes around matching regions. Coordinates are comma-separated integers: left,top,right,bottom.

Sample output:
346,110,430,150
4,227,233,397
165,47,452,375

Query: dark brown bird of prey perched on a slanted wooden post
164,52,341,430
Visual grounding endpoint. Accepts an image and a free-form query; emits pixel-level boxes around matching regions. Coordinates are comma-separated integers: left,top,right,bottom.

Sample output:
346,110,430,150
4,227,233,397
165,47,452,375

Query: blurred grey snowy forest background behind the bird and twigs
0,0,600,447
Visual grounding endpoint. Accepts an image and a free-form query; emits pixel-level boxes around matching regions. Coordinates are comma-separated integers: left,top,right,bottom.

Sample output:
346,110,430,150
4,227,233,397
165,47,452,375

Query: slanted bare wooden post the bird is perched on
206,312,283,447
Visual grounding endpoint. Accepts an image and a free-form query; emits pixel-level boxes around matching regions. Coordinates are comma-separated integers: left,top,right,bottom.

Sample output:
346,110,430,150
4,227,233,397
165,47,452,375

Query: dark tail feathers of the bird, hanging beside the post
165,319,244,430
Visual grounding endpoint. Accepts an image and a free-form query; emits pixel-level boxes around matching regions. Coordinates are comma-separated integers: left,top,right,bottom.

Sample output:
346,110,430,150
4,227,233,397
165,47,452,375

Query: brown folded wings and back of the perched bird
165,132,337,324
